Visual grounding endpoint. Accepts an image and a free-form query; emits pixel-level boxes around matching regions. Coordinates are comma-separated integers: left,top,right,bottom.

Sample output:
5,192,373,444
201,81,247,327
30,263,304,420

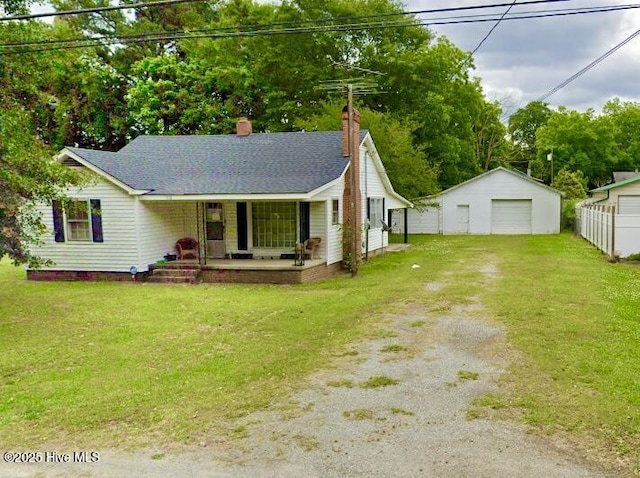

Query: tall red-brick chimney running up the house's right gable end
342,106,362,263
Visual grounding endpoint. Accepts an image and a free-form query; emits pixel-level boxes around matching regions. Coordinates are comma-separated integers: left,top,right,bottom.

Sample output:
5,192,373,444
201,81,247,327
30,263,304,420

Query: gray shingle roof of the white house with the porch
67,131,367,195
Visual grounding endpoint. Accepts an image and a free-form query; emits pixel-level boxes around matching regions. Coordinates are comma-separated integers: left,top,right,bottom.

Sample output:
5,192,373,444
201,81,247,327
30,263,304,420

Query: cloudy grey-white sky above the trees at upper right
404,0,640,117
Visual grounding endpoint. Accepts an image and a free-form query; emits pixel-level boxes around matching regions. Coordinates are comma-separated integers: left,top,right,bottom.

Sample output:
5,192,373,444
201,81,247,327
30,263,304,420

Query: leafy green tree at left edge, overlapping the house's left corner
0,22,85,267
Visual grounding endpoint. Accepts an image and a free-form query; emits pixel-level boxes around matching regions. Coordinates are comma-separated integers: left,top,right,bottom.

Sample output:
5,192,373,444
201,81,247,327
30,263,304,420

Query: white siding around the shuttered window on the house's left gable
33,176,143,272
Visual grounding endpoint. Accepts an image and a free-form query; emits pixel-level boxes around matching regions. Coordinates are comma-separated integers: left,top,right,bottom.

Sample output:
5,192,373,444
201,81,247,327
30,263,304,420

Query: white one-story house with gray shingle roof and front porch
28,111,412,283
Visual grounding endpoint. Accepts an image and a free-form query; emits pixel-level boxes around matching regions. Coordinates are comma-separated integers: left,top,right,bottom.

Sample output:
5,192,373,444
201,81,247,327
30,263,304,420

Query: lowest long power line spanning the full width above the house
0,2,640,55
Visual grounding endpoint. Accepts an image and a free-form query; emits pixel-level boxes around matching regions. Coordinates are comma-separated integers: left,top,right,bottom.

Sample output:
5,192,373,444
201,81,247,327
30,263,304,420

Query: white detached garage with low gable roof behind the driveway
393,167,562,234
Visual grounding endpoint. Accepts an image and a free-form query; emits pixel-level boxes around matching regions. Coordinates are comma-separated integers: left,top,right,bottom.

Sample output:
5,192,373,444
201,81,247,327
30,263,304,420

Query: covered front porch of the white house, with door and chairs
140,199,341,267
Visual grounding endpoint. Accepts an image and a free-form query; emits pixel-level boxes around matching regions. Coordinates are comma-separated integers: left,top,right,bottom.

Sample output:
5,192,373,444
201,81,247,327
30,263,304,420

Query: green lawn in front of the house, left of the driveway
0,241,446,447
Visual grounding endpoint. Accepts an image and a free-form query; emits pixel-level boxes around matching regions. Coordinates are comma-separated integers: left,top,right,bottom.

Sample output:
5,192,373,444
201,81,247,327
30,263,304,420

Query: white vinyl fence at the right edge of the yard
576,204,640,257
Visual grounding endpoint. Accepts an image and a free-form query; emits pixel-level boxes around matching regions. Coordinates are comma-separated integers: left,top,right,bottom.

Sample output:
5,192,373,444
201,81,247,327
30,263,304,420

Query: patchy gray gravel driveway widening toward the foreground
0,265,619,478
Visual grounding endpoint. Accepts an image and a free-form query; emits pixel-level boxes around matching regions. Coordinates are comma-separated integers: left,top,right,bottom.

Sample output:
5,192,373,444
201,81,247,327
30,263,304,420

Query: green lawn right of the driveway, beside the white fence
486,235,640,473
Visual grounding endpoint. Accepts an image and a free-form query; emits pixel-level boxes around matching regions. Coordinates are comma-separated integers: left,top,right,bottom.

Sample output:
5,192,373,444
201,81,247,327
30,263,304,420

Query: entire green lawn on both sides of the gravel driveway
0,234,640,473
